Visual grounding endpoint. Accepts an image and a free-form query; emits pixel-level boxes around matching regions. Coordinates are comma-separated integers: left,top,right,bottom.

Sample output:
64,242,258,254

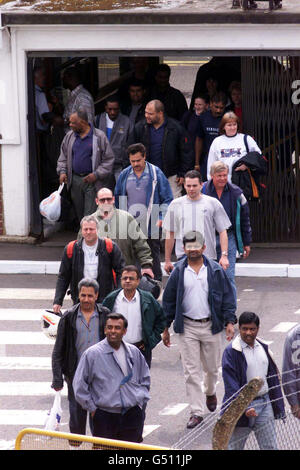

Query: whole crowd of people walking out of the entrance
32,60,300,448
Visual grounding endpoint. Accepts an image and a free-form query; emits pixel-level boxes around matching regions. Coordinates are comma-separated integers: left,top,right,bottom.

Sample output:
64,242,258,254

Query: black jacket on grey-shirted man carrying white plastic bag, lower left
52,304,110,389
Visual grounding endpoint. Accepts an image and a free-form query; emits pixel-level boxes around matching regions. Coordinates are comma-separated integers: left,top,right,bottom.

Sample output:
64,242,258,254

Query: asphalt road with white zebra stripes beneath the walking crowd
0,275,300,450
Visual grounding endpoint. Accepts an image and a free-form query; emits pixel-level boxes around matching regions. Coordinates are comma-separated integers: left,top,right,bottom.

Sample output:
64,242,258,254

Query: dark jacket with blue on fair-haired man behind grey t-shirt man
202,180,252,254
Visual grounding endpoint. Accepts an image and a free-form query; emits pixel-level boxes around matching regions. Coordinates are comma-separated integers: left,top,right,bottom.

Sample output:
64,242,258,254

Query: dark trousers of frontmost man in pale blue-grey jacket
93,406,144,442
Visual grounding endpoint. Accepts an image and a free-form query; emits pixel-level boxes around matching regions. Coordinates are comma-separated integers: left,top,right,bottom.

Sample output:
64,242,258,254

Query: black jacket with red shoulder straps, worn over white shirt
53,238,125,305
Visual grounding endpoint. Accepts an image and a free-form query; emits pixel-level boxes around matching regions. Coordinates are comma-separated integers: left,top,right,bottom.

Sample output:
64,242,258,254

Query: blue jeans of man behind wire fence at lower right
228,394,277,450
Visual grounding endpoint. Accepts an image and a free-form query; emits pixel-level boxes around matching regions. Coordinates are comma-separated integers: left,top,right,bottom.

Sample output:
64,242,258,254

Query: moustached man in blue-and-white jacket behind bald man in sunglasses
115,144,173,281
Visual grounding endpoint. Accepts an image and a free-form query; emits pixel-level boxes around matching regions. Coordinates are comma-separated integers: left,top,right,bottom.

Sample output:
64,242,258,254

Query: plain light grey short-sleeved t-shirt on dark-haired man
163,194,231,259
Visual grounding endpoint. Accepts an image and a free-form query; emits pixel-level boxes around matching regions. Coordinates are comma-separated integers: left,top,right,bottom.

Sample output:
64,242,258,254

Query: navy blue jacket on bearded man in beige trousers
162,256,237,335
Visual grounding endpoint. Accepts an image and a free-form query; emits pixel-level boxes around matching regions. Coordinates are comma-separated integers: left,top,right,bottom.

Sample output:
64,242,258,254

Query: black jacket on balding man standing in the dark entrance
128,117,194,178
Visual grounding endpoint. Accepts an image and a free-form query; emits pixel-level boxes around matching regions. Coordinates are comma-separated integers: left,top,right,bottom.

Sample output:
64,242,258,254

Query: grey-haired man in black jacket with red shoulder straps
53,216,125,313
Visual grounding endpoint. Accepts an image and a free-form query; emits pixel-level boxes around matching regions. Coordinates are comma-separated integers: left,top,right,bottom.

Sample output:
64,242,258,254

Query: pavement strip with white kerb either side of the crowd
0,226,300,278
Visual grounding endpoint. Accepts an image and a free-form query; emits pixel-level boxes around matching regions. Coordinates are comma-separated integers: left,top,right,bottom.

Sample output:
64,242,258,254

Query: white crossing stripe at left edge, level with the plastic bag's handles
0,381,67,396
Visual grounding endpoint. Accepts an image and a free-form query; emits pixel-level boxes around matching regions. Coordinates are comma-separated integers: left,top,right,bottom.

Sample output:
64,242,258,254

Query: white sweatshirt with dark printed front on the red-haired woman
207,134,261,183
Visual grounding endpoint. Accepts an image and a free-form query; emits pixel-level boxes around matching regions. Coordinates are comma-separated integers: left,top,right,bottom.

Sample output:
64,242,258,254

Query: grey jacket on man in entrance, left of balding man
96,113,133,169
